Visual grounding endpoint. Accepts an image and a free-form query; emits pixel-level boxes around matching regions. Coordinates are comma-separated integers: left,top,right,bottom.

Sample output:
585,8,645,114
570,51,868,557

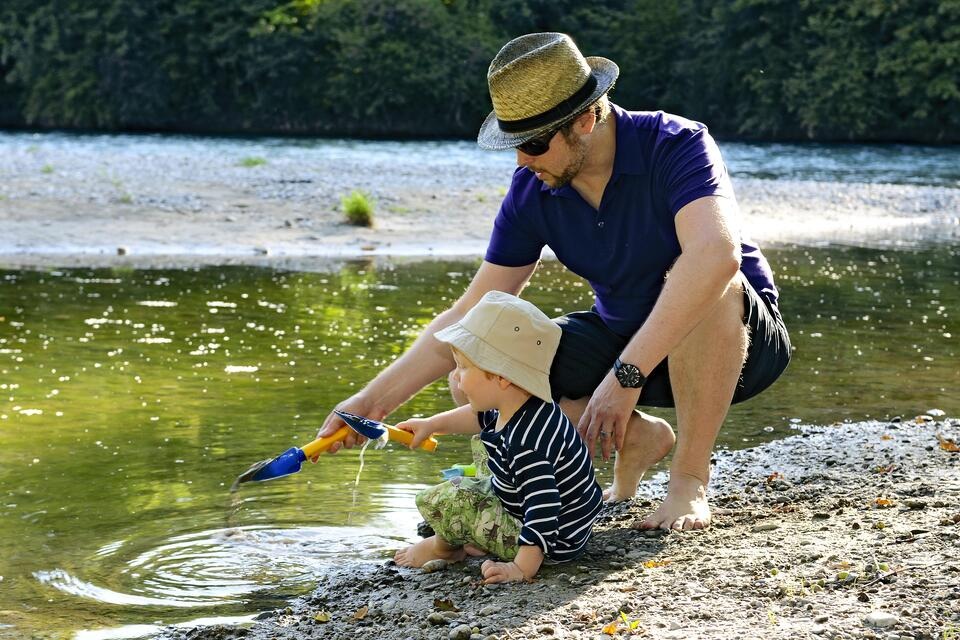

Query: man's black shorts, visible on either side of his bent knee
550,275,791,407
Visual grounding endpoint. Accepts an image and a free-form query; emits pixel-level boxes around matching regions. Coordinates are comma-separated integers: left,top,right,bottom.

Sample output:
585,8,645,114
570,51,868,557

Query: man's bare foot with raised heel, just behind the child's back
603,412,676,502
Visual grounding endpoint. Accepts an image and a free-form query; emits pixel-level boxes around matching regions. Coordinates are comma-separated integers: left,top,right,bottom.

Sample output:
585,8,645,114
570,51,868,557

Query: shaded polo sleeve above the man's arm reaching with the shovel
484,168,545,267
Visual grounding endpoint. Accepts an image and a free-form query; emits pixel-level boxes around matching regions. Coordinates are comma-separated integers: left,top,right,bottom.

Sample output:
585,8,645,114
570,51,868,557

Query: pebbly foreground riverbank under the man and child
156,411,960,640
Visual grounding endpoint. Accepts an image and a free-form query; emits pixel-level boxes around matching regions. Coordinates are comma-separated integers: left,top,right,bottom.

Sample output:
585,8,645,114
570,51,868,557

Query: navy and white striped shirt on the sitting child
477,396,603,561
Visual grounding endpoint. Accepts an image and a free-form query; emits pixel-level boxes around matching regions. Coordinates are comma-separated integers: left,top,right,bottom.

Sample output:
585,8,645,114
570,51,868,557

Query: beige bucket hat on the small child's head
434,291,561,402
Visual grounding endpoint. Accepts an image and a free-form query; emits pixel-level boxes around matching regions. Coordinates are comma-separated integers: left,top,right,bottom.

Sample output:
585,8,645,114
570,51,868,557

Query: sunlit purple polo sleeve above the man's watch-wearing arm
654,125,734,216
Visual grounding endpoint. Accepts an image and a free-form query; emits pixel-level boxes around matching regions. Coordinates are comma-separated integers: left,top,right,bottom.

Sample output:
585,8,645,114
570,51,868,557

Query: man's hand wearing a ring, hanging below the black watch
577,371,640,460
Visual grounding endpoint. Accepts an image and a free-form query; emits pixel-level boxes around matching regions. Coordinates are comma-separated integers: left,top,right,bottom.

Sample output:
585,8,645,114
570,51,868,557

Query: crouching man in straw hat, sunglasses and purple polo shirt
320,33,790,529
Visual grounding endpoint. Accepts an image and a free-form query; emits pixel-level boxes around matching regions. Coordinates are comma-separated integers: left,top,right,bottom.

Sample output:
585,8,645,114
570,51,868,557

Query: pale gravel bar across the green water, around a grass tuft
0,137,960,269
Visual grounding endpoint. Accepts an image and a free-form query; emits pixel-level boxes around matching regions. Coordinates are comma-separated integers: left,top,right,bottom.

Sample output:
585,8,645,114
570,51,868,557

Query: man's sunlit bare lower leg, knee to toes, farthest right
636,275,748,529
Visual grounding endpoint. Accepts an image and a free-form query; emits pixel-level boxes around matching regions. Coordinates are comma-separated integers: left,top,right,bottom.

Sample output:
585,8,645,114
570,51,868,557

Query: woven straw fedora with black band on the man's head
477,33,620,150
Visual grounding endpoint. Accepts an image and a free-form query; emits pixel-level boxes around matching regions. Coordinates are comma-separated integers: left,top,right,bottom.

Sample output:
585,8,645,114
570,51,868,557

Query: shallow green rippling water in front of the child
0,246,960,639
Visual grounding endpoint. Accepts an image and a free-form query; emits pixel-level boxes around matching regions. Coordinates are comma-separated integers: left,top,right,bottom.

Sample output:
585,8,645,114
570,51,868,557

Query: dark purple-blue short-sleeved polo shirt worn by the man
485,105,778,336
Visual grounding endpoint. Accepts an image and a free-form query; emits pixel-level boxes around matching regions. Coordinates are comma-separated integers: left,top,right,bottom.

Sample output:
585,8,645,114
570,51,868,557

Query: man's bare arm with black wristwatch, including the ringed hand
577,196,740,459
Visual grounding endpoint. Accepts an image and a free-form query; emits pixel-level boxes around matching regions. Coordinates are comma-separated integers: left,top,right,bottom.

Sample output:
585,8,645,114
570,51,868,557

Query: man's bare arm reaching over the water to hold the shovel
318,262,537,453
